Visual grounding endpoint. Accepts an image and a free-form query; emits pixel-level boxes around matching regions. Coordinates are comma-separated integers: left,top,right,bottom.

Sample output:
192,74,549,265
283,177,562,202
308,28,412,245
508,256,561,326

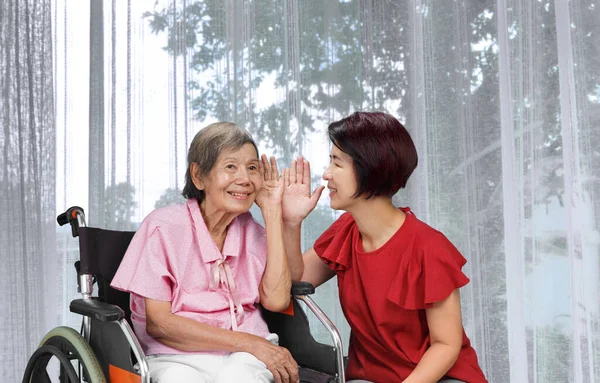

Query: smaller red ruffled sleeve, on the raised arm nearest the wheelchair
313,213,355,272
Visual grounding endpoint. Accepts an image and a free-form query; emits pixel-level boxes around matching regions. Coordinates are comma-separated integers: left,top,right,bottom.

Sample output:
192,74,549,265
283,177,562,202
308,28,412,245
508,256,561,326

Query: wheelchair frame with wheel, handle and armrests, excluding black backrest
23,206,346,383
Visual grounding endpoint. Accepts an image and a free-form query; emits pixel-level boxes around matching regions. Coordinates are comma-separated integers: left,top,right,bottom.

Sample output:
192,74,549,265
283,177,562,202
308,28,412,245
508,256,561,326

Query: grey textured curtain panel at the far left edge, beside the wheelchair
0,0,55,381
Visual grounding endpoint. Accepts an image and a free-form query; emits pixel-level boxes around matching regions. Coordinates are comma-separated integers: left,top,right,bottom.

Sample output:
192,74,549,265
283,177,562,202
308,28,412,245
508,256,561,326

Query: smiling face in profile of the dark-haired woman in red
323,145,358,210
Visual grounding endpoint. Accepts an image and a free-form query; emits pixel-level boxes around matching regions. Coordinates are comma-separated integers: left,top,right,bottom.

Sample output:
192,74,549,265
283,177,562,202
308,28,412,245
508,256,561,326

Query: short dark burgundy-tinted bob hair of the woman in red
328,112,418,199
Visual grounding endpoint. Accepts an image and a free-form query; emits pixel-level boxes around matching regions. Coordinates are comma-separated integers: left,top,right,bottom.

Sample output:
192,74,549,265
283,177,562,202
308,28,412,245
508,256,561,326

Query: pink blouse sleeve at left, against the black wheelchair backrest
111,222,175,301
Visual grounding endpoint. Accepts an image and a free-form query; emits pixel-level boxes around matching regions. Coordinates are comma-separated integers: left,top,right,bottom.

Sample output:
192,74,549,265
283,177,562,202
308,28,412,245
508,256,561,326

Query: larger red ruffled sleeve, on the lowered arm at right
386,232,469,310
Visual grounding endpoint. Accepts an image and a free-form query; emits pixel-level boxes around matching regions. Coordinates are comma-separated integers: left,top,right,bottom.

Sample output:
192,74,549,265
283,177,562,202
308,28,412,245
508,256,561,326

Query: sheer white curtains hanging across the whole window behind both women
0,0,600,383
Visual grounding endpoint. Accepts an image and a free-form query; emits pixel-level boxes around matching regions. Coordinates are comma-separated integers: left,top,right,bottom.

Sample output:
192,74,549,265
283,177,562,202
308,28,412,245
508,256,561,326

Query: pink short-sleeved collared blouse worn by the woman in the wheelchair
111,200,269,355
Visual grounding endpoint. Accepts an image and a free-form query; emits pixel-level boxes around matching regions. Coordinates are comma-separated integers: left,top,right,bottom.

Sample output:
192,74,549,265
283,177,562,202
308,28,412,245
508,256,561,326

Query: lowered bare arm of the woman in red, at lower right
404,289,463,383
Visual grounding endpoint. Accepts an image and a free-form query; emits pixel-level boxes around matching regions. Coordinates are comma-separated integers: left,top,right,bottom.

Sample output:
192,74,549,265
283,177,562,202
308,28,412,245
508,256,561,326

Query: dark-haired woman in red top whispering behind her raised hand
283,112,486,383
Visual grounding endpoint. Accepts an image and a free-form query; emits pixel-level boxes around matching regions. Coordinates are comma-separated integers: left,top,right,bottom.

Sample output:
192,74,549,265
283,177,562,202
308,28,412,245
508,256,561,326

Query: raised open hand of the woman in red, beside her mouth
282,156,325,224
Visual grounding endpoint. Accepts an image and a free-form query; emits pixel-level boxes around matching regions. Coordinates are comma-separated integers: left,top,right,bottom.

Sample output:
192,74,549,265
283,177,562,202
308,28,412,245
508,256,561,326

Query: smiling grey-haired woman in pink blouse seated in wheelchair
112,122,298,383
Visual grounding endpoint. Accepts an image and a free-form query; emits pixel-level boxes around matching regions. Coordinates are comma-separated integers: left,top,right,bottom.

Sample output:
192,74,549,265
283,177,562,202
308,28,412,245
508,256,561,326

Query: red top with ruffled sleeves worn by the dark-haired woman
314,208,487,383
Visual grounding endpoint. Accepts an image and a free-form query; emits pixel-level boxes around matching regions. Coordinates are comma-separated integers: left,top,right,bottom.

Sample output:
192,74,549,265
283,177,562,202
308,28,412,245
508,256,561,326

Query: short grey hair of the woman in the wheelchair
181,122,258,202
